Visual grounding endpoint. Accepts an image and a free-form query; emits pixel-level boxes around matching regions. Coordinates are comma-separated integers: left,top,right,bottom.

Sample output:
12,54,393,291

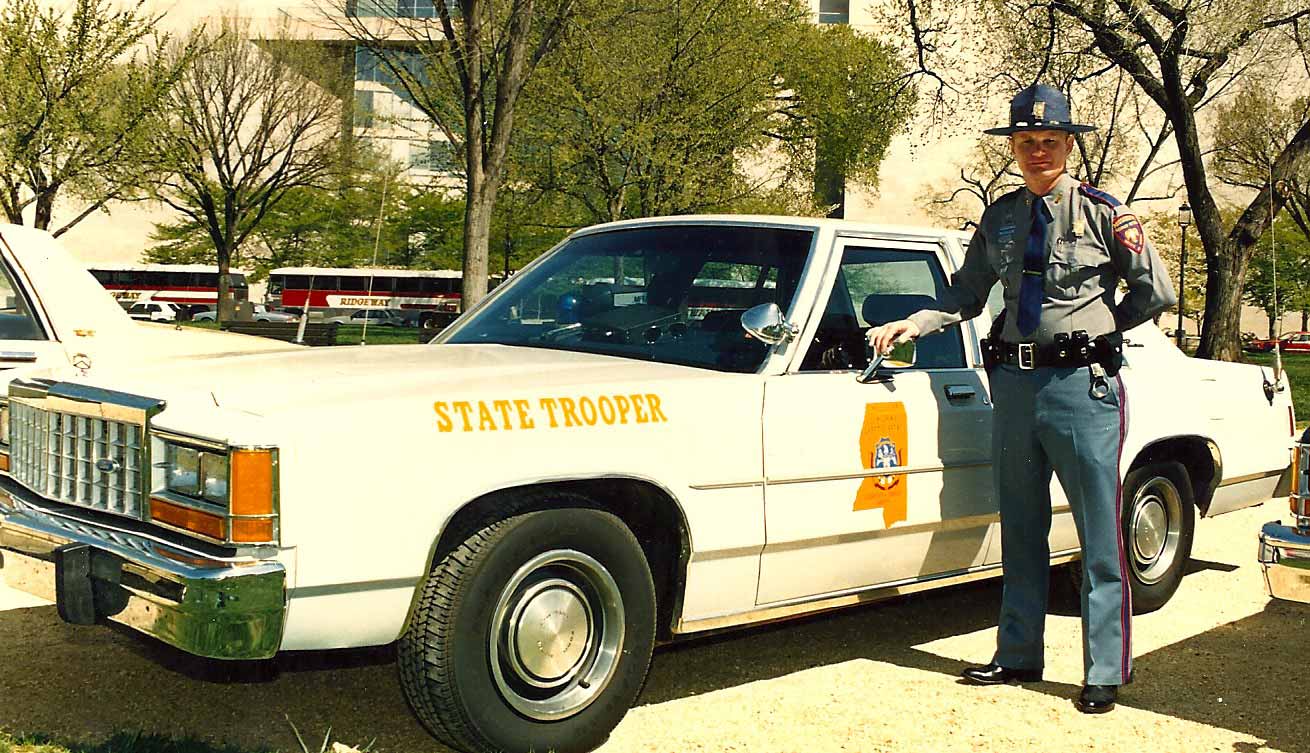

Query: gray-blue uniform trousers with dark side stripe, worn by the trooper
990,364,1132,685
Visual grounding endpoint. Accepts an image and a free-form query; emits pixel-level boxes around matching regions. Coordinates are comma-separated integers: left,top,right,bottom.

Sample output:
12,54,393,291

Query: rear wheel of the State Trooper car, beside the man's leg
1123,462,1196,614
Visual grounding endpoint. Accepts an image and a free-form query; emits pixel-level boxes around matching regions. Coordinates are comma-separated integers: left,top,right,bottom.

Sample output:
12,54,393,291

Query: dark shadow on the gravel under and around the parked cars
0,563,1310,753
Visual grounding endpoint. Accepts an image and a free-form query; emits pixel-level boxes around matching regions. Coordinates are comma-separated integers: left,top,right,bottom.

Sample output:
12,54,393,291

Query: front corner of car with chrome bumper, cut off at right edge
1260,430,1310,604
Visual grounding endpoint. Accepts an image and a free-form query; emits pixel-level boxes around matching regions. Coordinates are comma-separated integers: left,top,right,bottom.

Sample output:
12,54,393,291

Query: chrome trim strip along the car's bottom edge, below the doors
673,551,1078,634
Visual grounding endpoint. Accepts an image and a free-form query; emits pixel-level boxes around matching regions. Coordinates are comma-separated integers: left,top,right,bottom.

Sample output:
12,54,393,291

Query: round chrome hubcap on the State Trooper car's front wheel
489,549,624,720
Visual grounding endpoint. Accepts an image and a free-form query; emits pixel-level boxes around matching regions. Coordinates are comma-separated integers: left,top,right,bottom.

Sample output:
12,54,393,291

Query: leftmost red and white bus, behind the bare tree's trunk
88,263,250,309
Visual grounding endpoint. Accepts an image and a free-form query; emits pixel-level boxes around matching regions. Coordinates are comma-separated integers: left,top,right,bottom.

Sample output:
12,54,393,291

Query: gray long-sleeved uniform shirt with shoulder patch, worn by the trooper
909,174,1178,344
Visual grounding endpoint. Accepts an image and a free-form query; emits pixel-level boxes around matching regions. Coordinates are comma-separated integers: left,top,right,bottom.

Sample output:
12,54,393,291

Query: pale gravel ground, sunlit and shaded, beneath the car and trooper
0,500,1310,753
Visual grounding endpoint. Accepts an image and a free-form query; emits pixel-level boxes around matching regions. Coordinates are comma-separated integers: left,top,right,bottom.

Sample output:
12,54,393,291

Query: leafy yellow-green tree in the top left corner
0,0,194,236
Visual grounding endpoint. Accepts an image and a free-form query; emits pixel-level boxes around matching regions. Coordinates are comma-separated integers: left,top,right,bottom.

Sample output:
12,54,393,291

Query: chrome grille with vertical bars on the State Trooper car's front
9,401,145,519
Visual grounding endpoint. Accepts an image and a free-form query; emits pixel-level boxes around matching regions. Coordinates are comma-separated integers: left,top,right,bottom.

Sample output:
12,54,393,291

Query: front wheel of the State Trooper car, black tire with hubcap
397,496,655,753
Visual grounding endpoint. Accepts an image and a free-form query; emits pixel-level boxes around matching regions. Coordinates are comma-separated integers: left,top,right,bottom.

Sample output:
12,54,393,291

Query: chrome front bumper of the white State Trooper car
0,478,287,659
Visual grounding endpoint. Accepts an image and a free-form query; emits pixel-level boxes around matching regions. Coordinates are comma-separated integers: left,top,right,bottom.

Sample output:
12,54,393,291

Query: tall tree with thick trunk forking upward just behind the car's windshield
325,0,575,306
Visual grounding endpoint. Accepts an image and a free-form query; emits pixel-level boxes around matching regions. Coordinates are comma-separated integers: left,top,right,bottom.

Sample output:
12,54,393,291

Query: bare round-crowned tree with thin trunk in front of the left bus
155,17,342,318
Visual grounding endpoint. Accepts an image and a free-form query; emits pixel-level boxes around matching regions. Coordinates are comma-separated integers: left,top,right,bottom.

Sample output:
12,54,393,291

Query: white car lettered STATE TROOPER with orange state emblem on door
0,216,1294,753
